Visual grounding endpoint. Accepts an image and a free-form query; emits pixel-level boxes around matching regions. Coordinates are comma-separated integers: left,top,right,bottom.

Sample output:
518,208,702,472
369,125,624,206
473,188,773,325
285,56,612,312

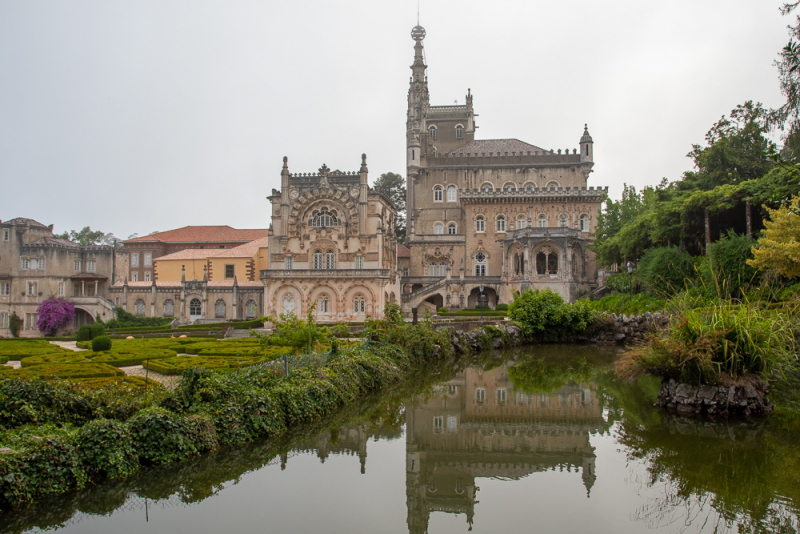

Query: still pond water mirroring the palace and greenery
0,346,800,534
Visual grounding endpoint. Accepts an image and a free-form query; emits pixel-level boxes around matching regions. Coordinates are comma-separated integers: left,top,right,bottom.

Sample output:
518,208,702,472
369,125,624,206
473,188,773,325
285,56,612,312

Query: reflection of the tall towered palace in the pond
406,366,605,533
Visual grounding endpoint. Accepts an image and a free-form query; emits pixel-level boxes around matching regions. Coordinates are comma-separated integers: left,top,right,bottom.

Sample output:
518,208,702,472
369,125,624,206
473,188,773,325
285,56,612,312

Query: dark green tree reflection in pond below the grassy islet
618,404,800,533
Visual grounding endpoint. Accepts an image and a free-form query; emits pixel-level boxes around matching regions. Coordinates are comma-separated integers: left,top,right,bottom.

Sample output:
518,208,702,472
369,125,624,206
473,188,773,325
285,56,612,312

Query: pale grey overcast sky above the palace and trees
0,0,791,237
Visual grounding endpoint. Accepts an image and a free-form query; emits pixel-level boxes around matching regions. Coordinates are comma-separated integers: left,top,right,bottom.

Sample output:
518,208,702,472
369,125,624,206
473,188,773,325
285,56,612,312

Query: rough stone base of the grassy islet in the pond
656,376,773,417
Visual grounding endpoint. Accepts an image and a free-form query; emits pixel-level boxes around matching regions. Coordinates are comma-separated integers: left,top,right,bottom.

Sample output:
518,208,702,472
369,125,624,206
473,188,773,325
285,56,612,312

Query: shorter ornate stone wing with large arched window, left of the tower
260,155,399,322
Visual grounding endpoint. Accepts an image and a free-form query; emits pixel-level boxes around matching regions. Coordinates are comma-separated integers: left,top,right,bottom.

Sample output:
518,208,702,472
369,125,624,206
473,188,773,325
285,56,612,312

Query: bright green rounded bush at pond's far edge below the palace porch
508,289,595,341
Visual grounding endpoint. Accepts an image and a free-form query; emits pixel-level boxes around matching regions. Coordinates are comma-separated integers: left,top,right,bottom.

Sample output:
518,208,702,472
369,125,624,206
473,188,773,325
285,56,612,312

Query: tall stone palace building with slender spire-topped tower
401,26,608,311
